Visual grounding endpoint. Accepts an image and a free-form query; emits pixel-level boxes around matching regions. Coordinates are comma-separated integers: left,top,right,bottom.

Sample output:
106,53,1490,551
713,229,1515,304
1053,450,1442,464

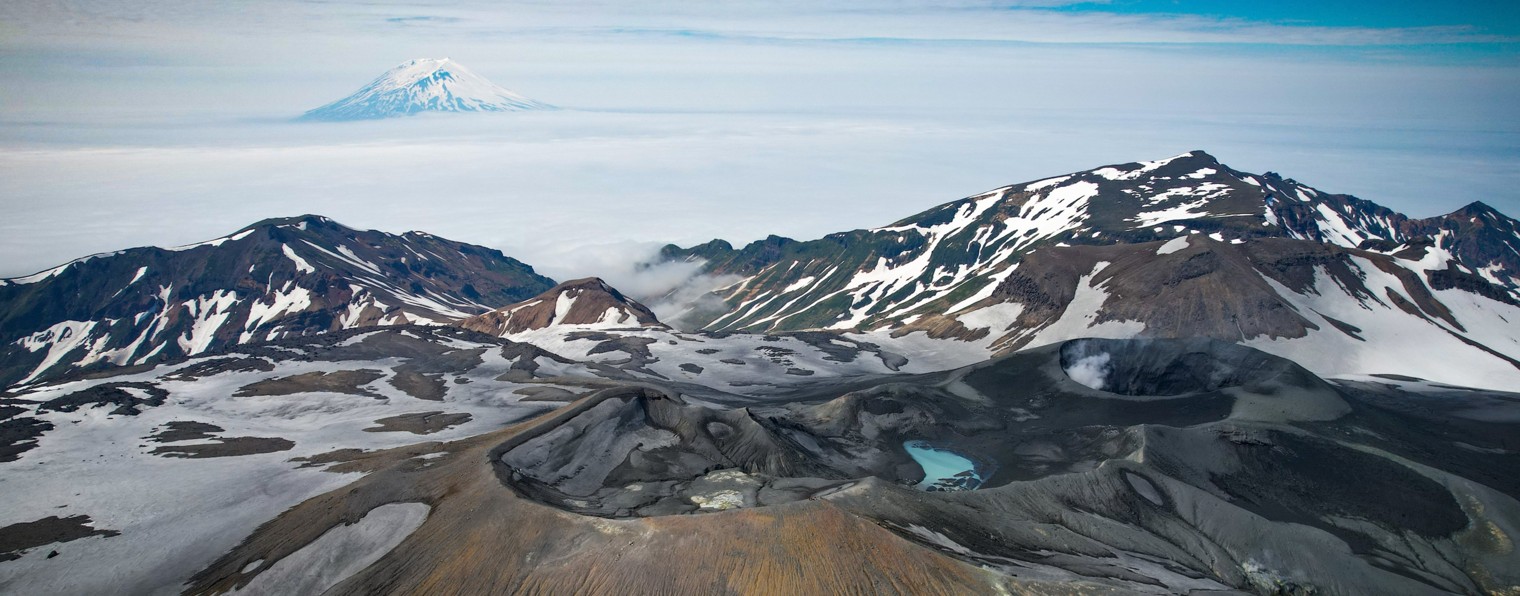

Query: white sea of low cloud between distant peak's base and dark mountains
0,104,1520,277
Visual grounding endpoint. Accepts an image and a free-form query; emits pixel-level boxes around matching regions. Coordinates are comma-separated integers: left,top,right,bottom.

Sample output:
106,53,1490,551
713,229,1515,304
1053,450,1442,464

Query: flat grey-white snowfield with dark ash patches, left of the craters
0,320,944,594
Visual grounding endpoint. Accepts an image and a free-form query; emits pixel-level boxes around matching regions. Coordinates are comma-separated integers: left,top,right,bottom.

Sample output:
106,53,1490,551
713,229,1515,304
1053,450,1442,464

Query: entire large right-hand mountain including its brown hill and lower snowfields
663,151,1520,388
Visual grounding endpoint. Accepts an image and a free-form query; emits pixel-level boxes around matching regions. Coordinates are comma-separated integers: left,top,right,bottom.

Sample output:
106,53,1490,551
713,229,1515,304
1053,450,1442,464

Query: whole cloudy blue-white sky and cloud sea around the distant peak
0,0,1520,277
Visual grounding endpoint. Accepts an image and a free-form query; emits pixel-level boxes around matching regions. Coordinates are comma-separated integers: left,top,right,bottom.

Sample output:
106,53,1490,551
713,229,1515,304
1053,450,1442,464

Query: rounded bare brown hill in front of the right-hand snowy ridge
930,234,1477,353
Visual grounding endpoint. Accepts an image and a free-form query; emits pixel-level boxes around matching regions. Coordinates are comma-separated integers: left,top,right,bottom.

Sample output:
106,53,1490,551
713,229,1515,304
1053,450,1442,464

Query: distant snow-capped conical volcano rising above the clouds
301,58,553,120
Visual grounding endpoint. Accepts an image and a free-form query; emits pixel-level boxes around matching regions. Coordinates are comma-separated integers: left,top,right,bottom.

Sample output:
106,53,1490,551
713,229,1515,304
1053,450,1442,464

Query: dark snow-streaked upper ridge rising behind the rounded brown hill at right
658,151,1520,330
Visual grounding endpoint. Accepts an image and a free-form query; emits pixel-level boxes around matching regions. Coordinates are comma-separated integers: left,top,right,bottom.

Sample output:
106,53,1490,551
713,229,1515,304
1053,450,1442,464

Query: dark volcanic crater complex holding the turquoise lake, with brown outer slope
160,341,1520,594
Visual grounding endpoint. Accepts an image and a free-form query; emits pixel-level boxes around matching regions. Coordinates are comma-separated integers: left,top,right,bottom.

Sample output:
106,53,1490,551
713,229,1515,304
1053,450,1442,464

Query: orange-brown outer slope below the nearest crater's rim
187,389,1107,594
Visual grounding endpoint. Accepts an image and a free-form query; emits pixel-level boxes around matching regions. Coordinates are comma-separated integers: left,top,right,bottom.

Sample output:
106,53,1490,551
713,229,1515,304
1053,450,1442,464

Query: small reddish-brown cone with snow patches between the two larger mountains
459,277,664,336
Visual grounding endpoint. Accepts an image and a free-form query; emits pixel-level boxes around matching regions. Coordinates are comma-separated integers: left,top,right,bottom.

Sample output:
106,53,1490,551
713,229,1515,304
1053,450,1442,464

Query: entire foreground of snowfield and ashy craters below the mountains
0,307,1520,594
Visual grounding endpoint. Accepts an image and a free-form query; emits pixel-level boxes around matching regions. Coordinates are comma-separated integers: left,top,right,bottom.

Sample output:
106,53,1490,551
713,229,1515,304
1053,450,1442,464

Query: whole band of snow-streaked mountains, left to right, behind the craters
11,152,1520,386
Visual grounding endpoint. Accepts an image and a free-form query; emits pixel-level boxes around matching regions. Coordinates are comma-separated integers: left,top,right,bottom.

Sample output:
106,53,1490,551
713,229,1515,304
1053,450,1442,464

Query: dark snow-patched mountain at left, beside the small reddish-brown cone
0,216,553,386
